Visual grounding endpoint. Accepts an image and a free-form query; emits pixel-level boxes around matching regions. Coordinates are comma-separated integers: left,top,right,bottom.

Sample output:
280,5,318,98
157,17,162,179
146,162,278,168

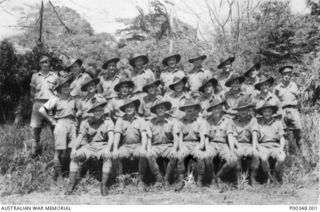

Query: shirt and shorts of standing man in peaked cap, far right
274,82,302,130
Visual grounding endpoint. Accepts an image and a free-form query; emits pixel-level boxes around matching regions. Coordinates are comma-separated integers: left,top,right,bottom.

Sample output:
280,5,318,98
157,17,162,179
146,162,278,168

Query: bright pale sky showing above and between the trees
0,0,309,39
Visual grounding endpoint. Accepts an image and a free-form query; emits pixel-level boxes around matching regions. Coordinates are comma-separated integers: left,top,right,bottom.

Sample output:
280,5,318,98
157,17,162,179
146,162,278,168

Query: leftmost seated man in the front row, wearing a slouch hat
65,100,114,196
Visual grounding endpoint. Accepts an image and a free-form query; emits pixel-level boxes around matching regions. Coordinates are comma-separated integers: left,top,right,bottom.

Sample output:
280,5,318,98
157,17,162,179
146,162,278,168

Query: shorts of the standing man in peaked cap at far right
282,107,302,130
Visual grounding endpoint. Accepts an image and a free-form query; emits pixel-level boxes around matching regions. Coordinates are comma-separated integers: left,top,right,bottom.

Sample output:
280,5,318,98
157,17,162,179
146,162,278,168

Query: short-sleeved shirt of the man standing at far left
30,71,59,100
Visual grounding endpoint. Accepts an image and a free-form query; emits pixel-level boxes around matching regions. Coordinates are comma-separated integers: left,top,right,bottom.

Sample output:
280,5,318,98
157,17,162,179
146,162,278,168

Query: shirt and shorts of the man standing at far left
30,72,59,127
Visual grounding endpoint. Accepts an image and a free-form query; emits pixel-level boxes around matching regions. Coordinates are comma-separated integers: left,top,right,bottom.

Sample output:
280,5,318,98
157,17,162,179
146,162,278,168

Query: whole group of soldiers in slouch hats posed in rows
30,53,301,196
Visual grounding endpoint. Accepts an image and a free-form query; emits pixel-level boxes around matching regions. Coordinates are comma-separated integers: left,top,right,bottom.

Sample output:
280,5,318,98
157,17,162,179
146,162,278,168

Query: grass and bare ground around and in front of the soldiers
0,112,320,204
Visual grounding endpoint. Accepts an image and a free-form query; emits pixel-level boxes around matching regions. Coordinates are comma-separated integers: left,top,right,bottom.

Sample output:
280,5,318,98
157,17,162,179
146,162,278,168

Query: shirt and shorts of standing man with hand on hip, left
43,97,77,150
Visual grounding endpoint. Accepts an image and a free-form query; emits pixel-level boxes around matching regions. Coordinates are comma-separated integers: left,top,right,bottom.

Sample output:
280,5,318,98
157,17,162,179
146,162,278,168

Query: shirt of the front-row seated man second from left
115,115,150,144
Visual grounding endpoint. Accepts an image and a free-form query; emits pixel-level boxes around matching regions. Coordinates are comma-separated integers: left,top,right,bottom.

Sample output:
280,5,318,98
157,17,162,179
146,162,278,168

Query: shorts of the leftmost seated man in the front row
75,142,110,160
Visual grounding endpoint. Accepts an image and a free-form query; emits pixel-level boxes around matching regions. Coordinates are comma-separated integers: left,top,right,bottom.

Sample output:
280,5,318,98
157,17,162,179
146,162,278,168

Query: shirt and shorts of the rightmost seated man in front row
258,119,286,161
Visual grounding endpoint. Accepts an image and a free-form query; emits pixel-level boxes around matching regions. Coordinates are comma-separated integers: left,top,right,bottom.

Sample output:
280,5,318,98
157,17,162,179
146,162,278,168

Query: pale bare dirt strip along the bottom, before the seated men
0,183,320,205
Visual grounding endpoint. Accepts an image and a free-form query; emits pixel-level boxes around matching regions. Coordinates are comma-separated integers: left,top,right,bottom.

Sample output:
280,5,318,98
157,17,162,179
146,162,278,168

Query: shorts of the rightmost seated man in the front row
258,142,286,161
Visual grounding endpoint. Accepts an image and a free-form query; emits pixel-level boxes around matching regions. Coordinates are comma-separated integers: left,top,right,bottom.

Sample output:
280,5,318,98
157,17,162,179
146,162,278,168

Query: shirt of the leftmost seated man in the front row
77,118,114,145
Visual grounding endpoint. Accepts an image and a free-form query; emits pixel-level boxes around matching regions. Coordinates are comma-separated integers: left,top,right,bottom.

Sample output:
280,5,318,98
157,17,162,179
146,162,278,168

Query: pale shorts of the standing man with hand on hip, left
53,118,77,150
